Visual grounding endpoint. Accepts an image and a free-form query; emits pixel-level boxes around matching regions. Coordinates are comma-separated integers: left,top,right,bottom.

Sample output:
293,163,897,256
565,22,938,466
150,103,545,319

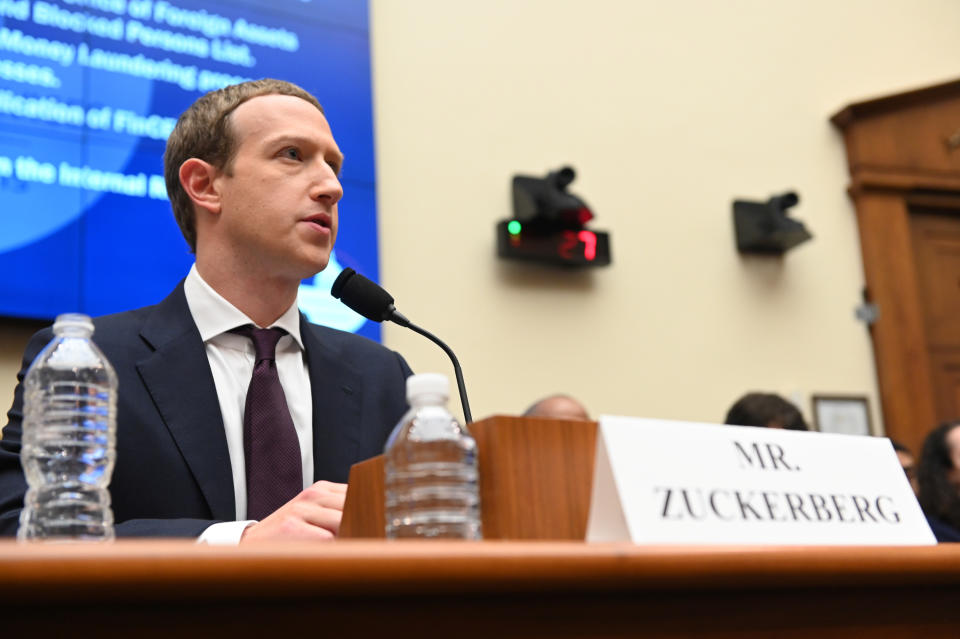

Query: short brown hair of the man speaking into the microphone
163,78,323,253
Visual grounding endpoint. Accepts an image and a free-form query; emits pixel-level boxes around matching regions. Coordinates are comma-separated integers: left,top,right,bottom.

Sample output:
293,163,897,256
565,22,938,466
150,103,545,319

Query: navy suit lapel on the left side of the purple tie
137,282,236,520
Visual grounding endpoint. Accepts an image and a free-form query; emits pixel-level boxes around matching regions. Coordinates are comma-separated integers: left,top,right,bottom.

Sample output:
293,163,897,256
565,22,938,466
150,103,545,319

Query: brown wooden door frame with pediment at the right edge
832,81,960,453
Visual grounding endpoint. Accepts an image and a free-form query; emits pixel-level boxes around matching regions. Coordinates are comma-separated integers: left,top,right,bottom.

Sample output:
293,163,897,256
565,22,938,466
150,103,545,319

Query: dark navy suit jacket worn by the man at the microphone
0,282,410,537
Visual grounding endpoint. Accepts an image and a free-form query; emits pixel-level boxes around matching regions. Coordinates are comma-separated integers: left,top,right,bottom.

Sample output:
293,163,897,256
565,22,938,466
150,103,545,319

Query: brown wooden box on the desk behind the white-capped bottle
340,417,597,540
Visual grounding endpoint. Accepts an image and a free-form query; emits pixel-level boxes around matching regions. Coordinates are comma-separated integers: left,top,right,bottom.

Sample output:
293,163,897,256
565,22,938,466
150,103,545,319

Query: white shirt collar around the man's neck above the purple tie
183,264,303,349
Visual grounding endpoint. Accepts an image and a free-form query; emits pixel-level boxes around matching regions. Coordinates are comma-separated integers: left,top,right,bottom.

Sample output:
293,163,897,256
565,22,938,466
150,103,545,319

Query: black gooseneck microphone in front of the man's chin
330,268,473,424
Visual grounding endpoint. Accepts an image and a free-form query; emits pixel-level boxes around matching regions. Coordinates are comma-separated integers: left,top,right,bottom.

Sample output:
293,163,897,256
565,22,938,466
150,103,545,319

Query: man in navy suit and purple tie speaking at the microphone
0,80,410,543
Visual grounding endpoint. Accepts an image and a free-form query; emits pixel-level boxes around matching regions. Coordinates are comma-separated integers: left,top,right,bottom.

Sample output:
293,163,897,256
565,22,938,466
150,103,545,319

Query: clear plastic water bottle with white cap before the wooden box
385,373,481,539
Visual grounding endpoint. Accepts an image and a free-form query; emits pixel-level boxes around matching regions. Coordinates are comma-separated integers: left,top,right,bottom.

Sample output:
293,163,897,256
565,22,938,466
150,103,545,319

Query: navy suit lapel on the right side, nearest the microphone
300,314,363,482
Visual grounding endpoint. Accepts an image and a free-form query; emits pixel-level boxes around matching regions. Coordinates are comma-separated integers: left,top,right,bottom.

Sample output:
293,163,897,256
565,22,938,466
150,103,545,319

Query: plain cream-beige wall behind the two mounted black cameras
0,0,960,436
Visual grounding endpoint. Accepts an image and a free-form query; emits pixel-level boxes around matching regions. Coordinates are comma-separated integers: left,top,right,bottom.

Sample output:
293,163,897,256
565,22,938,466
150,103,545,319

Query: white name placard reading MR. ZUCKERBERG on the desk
587,416,936,545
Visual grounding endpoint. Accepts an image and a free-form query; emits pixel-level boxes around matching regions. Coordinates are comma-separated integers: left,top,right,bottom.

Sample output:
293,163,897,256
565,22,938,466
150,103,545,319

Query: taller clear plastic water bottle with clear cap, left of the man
17,314,117,541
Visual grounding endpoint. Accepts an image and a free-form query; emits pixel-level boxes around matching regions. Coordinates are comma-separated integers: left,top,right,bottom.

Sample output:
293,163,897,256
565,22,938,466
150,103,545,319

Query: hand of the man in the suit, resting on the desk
240,481,347,544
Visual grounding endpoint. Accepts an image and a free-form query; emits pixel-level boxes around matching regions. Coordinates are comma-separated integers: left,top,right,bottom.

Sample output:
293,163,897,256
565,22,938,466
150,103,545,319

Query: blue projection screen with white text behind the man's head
0,0,380,340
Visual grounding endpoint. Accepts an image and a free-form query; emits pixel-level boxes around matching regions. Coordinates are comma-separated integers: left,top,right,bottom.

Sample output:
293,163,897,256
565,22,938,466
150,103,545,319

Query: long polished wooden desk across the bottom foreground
0,541,960,639
